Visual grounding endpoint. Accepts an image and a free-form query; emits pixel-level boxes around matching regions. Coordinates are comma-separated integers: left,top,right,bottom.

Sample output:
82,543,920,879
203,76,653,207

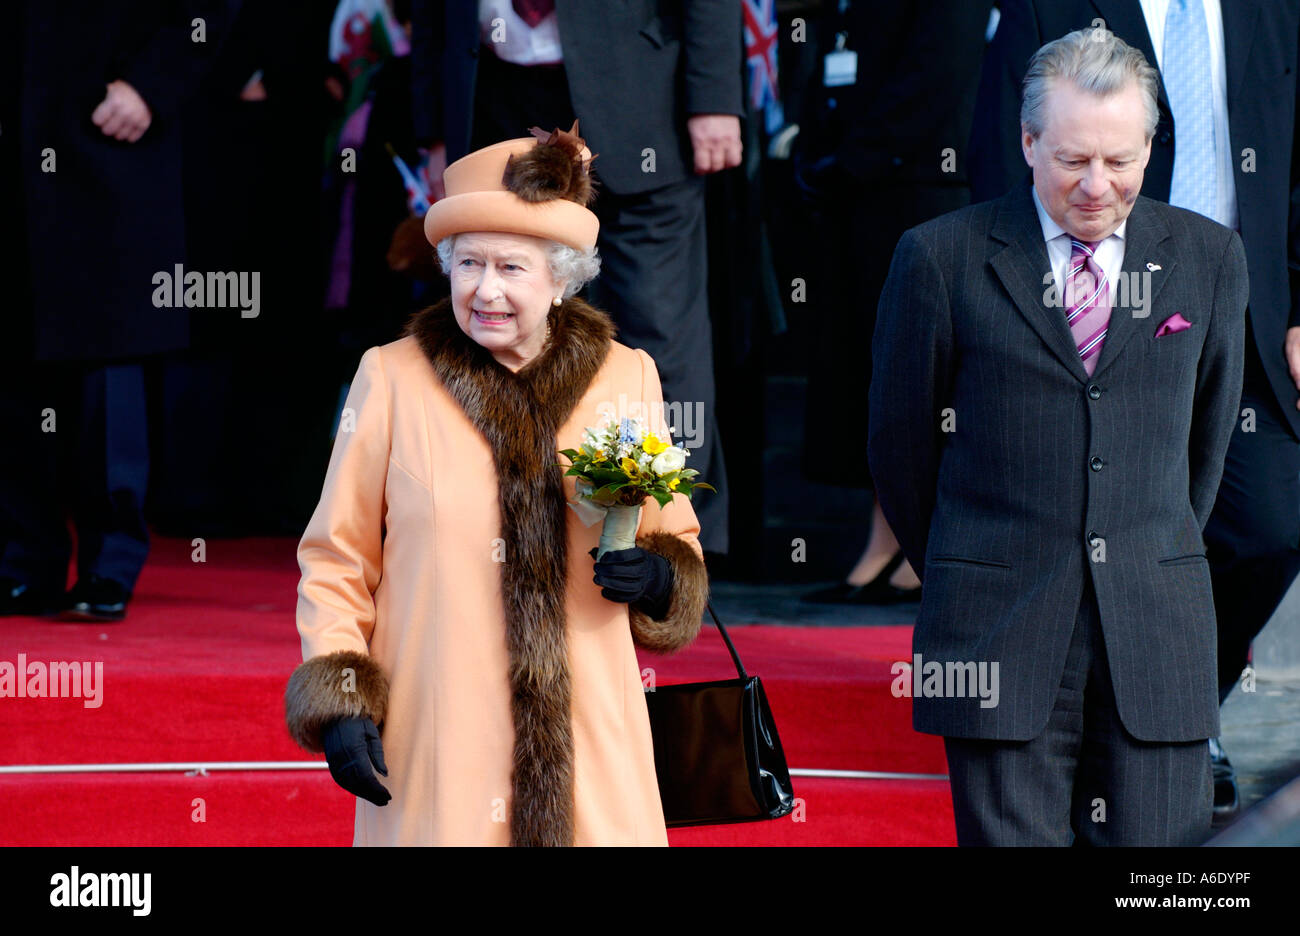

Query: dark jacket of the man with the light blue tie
970,0,1300,438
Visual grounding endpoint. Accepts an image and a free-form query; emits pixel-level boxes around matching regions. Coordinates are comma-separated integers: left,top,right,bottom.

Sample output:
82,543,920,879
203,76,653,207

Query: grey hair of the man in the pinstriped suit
1021,27,1160,140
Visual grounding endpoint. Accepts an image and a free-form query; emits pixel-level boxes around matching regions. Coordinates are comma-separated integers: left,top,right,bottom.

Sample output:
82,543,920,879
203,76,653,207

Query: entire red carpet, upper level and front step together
0,540,953,845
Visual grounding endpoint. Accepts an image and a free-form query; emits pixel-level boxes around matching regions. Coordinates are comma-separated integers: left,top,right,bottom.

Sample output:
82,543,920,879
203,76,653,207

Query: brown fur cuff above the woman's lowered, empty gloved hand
285,650,389,754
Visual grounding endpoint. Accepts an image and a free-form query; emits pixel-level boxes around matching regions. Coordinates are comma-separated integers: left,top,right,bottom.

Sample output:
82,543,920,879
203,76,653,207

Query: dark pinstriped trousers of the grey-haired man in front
944,584,1213,845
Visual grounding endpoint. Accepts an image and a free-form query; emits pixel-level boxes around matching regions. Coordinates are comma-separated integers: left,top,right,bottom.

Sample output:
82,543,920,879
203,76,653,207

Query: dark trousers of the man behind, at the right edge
1205,318,1300,701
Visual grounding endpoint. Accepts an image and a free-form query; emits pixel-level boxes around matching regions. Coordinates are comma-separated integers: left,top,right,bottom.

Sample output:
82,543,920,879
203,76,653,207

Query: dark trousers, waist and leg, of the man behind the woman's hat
471,48,728,553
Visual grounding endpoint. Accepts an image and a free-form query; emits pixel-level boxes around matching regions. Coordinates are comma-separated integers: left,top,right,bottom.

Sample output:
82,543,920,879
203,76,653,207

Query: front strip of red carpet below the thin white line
0,771,954,845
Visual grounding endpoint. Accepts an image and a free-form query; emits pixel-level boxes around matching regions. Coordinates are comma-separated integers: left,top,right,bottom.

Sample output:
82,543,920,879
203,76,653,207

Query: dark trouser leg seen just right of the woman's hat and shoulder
589,177,728,554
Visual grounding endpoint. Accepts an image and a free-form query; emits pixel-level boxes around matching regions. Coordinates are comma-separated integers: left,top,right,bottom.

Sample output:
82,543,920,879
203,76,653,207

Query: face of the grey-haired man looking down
1021,81,1151,242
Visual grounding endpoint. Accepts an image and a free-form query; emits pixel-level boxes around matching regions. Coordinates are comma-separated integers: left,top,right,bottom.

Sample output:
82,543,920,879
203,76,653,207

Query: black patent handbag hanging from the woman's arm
646,605,794,828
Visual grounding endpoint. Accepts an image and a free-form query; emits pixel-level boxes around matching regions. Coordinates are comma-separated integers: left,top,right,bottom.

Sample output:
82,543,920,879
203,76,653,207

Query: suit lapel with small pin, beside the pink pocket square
1092,196,1178,377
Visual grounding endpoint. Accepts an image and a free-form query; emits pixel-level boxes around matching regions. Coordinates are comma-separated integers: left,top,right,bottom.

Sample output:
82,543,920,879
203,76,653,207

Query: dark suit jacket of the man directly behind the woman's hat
411,0,741,195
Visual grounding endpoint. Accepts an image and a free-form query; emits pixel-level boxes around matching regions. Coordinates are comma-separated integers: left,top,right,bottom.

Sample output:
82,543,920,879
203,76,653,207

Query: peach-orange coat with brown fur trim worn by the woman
286,299,707,845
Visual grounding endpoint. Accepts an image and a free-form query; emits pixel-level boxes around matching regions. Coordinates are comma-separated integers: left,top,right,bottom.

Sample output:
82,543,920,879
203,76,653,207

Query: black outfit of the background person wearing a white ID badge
794,0,992,488
